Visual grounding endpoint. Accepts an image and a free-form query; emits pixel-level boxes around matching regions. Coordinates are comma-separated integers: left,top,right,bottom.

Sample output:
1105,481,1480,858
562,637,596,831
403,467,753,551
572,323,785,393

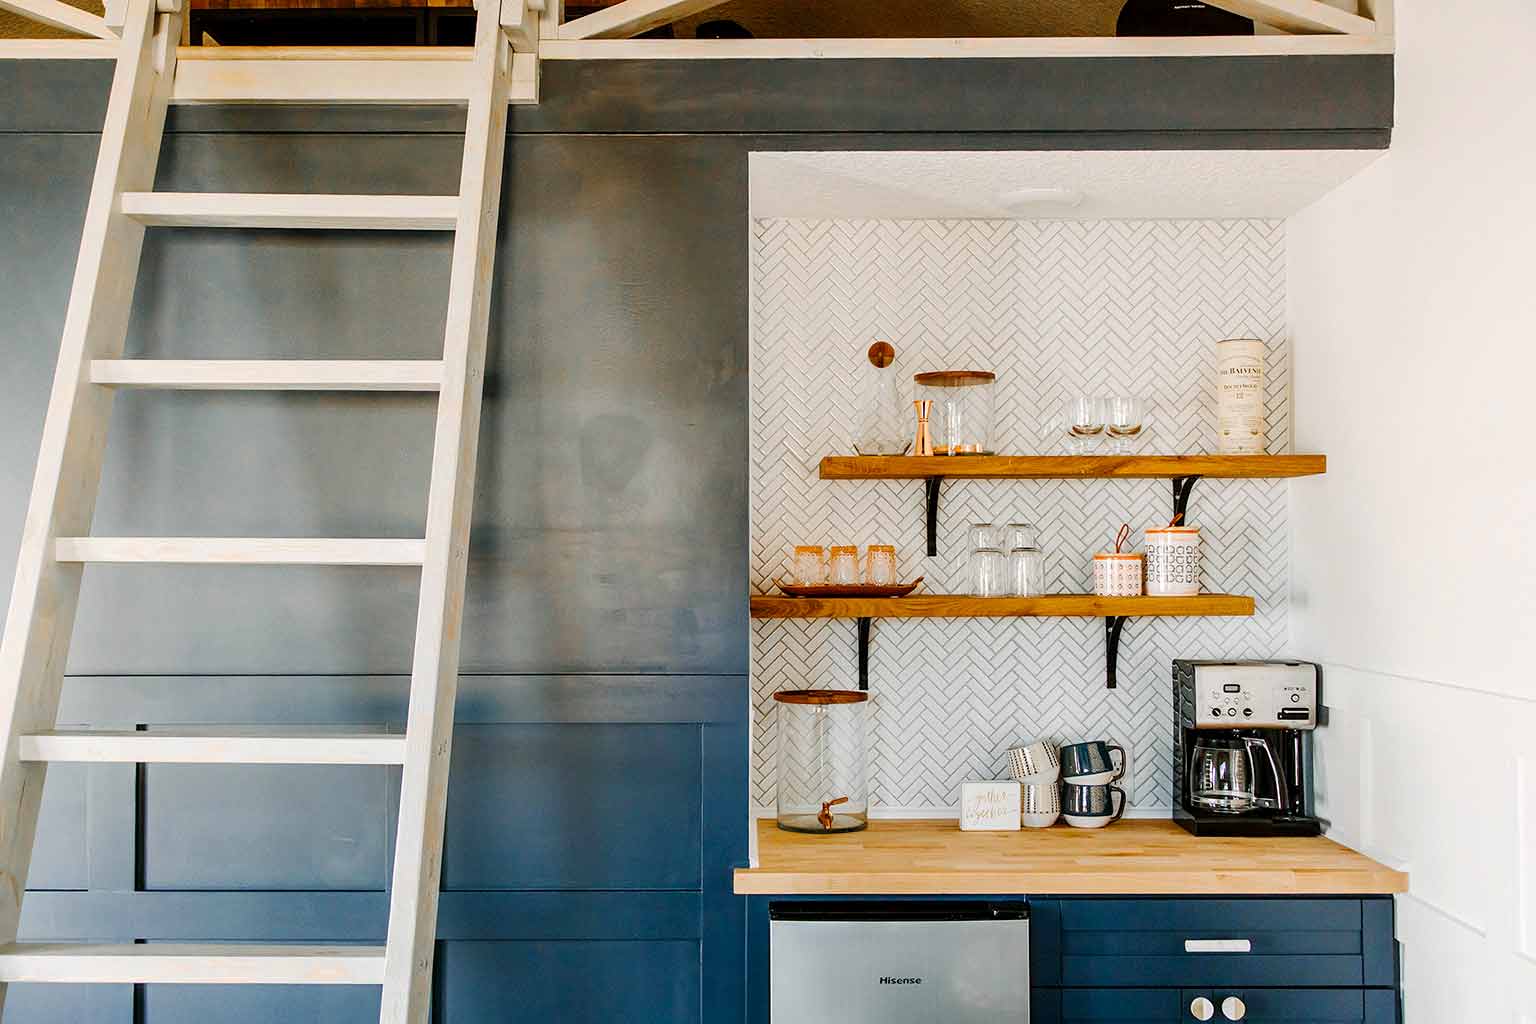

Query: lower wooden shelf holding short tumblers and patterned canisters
751,594,1253,619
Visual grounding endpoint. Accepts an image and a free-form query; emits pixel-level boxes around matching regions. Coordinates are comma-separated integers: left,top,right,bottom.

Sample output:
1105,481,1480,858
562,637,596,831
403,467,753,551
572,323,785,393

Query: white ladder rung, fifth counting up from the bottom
121,192,459,232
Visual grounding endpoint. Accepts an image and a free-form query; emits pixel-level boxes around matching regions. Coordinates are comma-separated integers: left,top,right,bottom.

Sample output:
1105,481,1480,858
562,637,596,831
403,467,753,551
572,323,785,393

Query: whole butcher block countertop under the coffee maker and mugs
736,820,1409,897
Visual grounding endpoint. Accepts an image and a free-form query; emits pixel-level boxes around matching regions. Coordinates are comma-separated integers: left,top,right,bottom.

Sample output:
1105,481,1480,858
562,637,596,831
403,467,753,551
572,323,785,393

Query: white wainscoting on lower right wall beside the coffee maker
1318,665,1536,1024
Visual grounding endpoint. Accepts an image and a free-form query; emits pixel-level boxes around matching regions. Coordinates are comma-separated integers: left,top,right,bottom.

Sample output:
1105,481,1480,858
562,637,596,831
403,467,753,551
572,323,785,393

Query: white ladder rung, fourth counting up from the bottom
91,359,442,391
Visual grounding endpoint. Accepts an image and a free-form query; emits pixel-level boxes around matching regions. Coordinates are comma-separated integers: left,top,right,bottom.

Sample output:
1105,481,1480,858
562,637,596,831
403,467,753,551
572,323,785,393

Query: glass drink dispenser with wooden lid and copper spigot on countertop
773,689,869,835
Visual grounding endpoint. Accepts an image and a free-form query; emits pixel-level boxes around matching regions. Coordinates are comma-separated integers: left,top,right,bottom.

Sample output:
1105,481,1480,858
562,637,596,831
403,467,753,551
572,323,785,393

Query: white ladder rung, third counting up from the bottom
54,537,427,565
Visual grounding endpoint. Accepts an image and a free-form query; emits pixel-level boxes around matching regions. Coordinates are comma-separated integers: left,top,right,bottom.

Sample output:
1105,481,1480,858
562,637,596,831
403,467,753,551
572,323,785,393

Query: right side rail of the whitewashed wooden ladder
379,0,518,1024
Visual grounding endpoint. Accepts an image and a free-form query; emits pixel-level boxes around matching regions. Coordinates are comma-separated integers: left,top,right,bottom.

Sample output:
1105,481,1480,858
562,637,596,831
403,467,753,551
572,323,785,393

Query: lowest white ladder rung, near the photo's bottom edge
0,943,384,986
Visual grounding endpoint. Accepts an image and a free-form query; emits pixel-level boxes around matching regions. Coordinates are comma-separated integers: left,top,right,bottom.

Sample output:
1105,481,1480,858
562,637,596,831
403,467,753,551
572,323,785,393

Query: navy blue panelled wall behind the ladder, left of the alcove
0,99,748,1024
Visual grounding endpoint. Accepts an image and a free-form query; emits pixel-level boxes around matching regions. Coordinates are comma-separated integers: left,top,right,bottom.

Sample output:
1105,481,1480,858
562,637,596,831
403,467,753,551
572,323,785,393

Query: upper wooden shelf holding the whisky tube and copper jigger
822,454,1329,481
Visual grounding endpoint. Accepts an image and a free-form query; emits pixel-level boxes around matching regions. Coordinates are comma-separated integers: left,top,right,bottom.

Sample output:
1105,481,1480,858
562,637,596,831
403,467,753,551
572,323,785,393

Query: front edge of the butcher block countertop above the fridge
734,867,1409,897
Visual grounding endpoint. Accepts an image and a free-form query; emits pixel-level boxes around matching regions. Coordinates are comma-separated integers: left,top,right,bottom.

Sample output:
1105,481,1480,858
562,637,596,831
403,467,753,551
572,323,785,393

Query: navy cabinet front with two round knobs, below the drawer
1031,989,1398,1024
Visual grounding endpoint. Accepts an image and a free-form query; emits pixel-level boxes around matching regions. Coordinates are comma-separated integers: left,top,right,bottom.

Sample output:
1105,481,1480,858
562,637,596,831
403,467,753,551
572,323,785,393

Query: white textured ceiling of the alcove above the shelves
751,149,1384,221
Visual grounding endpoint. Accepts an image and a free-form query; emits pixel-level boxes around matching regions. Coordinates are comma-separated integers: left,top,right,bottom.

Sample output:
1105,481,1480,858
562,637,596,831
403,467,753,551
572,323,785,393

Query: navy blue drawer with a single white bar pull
1061,898,1370,989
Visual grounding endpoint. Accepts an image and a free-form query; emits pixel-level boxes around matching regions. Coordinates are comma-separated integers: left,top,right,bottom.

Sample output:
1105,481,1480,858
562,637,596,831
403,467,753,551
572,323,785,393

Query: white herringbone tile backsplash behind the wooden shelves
751,220,1290,814
